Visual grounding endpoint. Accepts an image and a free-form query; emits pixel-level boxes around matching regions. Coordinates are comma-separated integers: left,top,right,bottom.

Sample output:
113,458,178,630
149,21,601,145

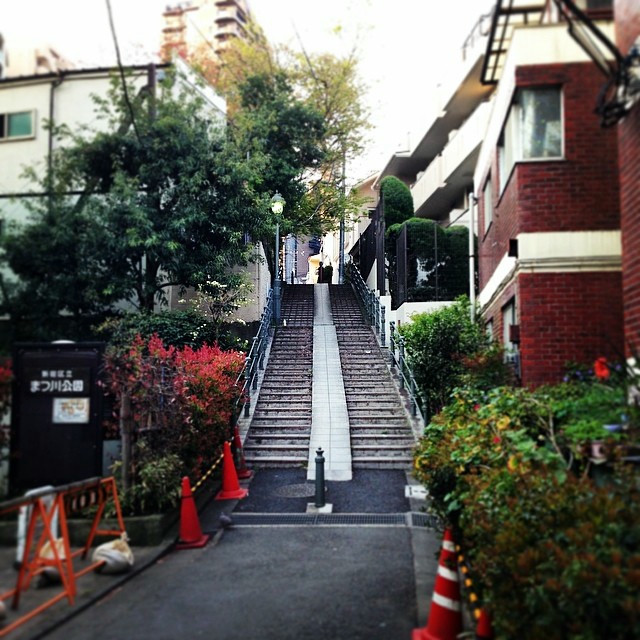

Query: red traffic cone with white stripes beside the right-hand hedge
412,529,462,640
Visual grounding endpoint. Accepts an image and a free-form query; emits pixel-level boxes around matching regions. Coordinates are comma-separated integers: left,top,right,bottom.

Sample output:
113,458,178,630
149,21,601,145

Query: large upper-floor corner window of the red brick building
498,87,563,192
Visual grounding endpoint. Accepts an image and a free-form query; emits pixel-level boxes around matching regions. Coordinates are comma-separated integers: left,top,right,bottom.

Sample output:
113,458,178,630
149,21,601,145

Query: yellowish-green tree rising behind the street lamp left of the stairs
195,25,369,276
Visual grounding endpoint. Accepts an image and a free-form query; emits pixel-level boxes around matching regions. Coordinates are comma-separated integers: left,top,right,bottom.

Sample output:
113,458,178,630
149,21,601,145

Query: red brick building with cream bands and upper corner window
474,2,624,386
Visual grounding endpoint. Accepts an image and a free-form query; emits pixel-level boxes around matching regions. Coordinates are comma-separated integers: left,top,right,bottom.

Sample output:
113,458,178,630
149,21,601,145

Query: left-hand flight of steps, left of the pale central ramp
244,285,313,469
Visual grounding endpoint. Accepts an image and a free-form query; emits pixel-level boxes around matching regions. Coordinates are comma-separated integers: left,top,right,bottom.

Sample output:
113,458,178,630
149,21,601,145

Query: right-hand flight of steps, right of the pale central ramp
329,285,415,469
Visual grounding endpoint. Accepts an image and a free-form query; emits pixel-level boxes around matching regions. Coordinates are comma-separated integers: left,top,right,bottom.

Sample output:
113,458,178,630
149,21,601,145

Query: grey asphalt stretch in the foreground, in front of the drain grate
47,526,416,640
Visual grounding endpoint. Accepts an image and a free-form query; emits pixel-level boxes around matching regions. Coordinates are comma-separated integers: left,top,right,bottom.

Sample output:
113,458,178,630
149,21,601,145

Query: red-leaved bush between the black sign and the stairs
105,335,244,512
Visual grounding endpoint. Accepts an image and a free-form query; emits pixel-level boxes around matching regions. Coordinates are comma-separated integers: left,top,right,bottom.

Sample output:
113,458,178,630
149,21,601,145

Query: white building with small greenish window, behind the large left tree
0,58,270,321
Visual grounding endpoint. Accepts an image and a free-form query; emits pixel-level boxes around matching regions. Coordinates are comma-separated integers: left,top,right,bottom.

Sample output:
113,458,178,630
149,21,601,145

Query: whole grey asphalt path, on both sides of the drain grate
33,469,430,640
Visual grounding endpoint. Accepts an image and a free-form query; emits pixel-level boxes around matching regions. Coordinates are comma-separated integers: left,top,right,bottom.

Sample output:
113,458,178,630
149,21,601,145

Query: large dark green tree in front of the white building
2,72,266,336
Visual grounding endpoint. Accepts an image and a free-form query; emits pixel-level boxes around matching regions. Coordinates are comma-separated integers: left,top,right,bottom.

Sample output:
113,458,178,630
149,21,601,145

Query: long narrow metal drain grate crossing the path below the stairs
212,513,439,528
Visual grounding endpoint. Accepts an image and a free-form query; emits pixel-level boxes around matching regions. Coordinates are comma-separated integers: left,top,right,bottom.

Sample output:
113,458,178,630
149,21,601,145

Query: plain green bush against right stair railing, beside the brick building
400,297,487,416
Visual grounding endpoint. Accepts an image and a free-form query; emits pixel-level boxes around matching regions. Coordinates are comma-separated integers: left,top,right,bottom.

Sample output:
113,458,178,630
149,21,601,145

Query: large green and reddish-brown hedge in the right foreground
414,372,640,640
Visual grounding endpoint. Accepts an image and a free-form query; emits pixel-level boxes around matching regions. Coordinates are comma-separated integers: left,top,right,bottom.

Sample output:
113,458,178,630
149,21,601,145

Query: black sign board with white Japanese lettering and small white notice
9,342,104,490
